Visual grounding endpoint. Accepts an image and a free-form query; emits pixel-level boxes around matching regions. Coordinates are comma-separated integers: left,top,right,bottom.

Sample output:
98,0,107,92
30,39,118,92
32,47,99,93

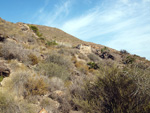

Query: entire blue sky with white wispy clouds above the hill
0,0,150,60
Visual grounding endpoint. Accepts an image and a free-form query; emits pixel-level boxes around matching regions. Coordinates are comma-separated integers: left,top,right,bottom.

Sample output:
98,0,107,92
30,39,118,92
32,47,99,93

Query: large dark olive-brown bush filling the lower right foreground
73,67,150,113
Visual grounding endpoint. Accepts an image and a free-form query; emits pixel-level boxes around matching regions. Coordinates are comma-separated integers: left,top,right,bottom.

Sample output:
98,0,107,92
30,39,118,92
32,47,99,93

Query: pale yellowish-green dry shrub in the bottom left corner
0,91,37,113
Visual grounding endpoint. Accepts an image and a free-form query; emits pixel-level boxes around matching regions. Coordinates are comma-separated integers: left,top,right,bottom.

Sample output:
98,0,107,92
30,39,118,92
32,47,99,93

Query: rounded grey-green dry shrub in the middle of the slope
38,54,72,80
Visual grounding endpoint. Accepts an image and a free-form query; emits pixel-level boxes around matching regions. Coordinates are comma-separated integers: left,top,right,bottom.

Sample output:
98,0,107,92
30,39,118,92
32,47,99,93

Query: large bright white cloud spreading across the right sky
62,0,150,59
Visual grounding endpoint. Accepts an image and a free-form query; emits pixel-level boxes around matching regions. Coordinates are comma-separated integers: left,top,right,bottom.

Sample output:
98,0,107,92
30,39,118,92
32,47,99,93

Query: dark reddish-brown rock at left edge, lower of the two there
0,62,10,77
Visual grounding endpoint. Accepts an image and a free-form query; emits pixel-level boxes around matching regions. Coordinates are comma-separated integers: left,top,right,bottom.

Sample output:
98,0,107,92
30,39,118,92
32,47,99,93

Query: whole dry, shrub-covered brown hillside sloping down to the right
0,18,150,113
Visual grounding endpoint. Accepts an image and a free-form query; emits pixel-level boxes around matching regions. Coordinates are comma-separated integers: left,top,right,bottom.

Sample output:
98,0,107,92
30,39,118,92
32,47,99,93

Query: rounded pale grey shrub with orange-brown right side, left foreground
6,71,48,98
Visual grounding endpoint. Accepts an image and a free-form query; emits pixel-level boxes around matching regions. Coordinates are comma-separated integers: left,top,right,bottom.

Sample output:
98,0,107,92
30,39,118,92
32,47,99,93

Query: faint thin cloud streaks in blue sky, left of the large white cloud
32,0,71,26
